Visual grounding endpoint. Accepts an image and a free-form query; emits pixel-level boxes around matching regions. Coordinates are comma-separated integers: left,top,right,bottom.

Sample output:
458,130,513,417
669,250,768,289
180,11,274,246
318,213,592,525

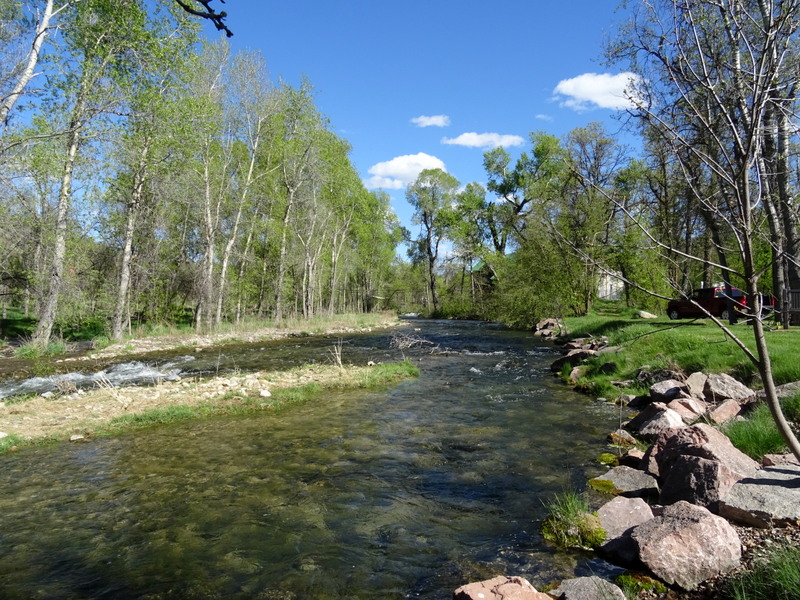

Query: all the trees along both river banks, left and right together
0,0,800,356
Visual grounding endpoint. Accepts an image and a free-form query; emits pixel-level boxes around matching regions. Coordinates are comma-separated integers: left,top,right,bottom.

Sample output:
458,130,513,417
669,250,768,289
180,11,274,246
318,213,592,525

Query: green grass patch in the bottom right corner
725,546,800,600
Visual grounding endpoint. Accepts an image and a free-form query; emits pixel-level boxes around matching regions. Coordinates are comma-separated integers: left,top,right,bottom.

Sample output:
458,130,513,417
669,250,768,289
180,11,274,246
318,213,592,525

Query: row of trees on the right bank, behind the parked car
407,0,800,332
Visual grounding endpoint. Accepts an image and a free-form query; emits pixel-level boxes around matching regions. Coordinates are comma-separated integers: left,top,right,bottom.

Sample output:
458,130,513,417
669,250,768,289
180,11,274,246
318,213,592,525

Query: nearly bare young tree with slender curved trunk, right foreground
612,0,800,458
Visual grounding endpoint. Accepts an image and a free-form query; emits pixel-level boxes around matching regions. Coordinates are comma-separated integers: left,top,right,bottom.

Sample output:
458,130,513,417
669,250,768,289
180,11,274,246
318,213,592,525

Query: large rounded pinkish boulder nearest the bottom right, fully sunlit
631,502,742,590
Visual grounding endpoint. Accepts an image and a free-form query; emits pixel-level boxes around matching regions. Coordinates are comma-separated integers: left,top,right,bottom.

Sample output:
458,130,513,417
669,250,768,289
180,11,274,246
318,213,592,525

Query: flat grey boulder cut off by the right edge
719,465,800,528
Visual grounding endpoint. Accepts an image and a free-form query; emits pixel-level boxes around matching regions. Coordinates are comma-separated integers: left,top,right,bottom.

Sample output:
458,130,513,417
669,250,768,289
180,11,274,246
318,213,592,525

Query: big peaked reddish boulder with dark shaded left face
642,424,758,510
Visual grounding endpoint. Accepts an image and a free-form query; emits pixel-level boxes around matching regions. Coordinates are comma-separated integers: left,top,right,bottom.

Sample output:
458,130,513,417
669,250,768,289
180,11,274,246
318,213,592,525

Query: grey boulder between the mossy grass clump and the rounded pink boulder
597,496,653,565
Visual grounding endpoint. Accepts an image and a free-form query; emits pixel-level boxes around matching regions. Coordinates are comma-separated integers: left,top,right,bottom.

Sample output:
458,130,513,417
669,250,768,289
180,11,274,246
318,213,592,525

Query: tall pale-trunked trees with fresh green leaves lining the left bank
0,0,401,343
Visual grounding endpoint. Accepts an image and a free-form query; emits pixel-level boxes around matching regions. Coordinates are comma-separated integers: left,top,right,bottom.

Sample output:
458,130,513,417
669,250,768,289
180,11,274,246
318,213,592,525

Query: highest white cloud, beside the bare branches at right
553,72,640,111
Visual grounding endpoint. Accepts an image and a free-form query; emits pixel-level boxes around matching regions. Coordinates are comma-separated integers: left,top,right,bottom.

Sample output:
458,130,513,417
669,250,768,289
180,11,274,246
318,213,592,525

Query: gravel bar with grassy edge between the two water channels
0,361,419,453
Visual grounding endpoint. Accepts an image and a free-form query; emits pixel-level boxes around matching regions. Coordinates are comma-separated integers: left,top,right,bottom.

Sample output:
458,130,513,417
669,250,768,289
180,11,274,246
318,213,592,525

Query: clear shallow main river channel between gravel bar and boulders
0,322,618,600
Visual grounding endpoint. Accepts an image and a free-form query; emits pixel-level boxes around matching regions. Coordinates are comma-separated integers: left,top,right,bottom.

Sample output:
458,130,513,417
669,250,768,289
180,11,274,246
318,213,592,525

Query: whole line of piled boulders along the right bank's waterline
453,319,800,600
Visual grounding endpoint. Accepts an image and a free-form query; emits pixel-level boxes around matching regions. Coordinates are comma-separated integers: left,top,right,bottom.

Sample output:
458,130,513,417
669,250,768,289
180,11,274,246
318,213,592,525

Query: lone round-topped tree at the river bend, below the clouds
406,169,459,313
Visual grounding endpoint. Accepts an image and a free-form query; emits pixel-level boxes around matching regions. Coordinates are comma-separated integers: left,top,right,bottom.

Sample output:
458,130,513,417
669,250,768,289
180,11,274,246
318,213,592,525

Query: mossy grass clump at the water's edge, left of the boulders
542,491,606,549
